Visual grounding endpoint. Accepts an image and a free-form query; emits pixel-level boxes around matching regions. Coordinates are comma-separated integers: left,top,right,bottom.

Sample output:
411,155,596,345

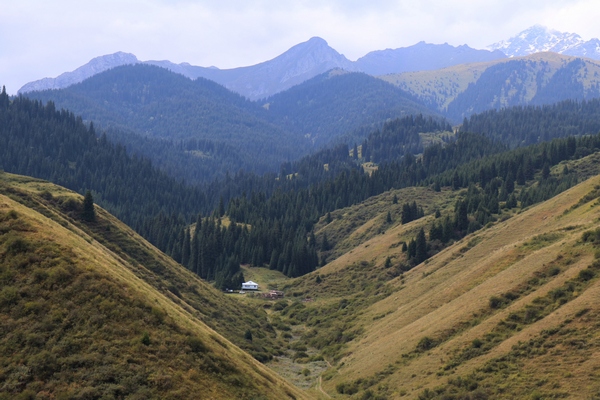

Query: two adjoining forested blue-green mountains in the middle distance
27,65,431,183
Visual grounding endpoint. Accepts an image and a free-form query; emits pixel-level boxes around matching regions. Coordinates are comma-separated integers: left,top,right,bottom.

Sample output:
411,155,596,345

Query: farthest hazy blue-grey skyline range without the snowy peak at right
19,37,504,100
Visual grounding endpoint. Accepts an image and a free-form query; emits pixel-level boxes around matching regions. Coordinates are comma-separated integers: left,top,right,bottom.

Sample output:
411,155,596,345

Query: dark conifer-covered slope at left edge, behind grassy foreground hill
0,94,207,232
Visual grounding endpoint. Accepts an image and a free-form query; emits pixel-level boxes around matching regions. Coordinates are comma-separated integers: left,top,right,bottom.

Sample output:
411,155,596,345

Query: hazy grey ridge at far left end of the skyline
18,51,139,94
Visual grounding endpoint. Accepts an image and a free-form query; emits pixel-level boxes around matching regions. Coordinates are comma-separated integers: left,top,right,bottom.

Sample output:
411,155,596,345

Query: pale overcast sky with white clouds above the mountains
0,0,600,94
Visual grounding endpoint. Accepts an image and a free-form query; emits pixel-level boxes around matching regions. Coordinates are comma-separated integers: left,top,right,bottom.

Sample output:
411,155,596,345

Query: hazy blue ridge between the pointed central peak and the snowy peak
355,42,506,76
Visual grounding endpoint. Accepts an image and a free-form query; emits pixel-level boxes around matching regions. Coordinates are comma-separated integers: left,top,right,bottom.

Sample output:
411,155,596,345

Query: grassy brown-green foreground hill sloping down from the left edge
0,173,305,399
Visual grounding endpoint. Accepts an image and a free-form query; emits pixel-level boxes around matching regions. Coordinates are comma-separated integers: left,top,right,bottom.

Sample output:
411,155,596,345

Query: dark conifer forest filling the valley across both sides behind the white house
2,85,597,286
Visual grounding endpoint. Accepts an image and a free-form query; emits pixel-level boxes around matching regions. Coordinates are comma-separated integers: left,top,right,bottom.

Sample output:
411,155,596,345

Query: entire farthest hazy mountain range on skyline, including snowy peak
19,25,600,100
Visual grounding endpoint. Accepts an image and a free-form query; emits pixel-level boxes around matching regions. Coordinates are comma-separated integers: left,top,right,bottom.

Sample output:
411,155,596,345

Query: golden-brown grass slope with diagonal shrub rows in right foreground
315,171,600,398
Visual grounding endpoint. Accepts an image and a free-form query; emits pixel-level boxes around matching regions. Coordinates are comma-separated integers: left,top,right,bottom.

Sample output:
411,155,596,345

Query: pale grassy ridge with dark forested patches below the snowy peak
381,53,600,122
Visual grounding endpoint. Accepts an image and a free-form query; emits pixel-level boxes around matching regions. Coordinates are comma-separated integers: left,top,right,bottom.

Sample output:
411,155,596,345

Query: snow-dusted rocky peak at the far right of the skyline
488,25,600,60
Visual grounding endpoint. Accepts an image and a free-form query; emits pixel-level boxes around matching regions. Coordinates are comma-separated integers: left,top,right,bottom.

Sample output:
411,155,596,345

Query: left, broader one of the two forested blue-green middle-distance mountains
27,64,312,182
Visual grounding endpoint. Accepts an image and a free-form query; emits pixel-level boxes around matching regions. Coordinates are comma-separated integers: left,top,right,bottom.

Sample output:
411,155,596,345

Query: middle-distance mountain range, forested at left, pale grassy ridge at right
26,52,600,187
